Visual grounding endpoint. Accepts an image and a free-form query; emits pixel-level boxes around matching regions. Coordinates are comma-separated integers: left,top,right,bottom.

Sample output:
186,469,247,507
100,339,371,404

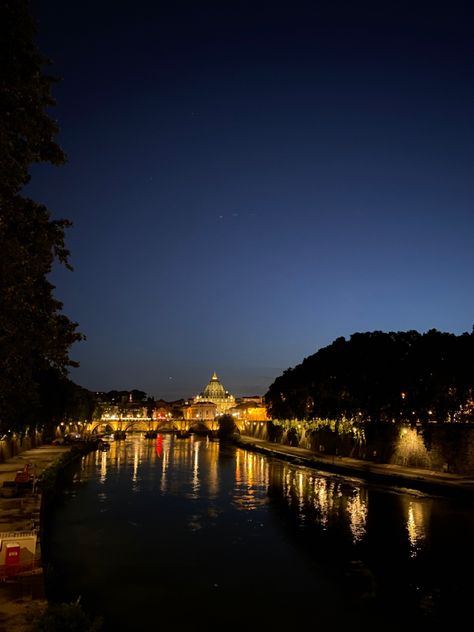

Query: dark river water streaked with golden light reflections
43,435,474,630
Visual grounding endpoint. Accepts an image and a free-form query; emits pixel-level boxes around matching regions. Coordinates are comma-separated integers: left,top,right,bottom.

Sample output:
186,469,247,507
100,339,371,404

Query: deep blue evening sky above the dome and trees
28,0,474,399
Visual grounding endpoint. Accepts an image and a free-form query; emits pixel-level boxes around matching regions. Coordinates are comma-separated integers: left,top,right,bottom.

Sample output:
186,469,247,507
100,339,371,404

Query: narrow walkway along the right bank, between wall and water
237,436,474,498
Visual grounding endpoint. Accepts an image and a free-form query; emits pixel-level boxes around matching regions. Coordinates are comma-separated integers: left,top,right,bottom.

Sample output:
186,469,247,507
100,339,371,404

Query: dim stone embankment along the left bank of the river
0,445,70,632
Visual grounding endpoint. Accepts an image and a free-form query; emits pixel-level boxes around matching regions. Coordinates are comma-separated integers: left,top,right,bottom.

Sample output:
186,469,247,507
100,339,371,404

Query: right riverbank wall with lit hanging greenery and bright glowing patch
242,420,474,476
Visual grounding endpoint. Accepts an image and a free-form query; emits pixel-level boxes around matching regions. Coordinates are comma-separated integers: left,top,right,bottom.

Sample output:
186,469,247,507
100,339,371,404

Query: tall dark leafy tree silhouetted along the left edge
0,0,82,429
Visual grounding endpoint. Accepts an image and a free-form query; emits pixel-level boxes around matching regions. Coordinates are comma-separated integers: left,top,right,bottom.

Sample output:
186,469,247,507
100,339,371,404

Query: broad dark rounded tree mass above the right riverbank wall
266,329,474,422
